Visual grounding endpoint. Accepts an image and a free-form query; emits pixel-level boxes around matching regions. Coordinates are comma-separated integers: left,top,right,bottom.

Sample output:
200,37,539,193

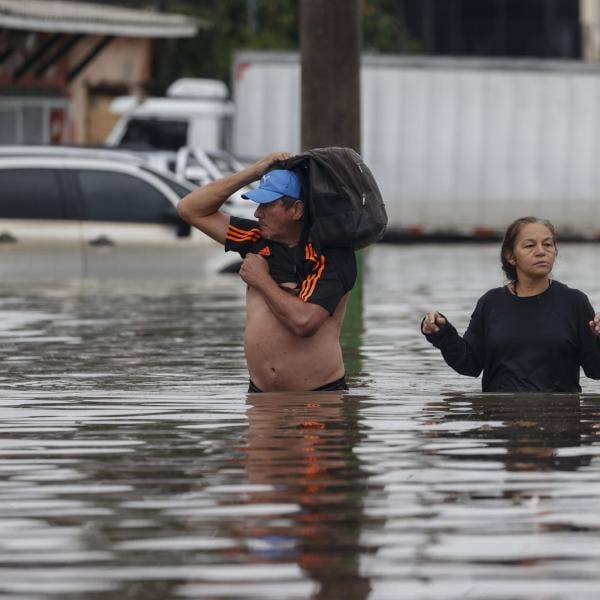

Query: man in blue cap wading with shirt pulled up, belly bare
178,152,356,392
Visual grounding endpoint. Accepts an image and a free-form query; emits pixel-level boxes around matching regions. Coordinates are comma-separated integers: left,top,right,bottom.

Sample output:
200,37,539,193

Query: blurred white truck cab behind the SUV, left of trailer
106,78,234,151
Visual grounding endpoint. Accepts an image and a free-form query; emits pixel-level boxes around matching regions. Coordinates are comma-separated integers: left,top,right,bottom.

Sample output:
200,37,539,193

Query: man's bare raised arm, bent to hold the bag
177,152,290,244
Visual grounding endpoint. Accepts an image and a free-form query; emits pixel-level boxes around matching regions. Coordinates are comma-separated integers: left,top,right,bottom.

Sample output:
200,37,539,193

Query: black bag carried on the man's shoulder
277,147,388,250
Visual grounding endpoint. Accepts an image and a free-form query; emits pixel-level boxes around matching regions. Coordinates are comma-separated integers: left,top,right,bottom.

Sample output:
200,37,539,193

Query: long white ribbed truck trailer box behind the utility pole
233,52,600,238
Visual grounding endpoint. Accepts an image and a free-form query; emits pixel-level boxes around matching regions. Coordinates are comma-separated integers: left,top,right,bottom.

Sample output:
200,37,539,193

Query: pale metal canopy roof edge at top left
0,0,202,38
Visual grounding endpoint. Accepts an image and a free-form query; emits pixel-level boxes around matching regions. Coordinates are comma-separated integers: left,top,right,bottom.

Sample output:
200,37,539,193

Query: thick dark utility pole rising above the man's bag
300,0,362,152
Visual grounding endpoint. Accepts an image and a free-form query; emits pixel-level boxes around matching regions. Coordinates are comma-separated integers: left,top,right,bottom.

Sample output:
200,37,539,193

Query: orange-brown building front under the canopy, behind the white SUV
0,30,152,144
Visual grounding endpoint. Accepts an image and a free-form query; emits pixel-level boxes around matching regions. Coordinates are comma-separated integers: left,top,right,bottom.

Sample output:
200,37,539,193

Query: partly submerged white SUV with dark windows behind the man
0,146,232,281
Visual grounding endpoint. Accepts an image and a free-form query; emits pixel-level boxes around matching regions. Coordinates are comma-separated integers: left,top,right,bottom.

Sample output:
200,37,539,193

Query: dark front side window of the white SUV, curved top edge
77,169,174,223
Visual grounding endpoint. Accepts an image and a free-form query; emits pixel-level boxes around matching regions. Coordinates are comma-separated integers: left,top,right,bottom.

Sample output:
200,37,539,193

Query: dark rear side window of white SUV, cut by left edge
0,169,66,219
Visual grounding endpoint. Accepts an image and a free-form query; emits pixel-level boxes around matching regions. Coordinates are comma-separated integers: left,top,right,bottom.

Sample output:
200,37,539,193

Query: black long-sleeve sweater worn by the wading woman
426,281,600,392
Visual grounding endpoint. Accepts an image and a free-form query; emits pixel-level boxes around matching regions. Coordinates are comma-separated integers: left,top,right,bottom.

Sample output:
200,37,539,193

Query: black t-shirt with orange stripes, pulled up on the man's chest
225,217,356,314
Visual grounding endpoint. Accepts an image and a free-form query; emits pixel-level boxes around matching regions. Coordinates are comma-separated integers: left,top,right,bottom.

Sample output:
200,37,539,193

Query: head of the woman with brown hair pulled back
506,223,557,279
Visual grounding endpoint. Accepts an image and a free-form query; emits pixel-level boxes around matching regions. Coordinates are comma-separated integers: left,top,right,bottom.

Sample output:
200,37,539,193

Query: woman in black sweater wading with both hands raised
421,217,600,392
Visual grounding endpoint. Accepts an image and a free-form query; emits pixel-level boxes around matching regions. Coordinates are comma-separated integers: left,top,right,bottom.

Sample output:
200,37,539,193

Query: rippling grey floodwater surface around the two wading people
0,246,600,600
